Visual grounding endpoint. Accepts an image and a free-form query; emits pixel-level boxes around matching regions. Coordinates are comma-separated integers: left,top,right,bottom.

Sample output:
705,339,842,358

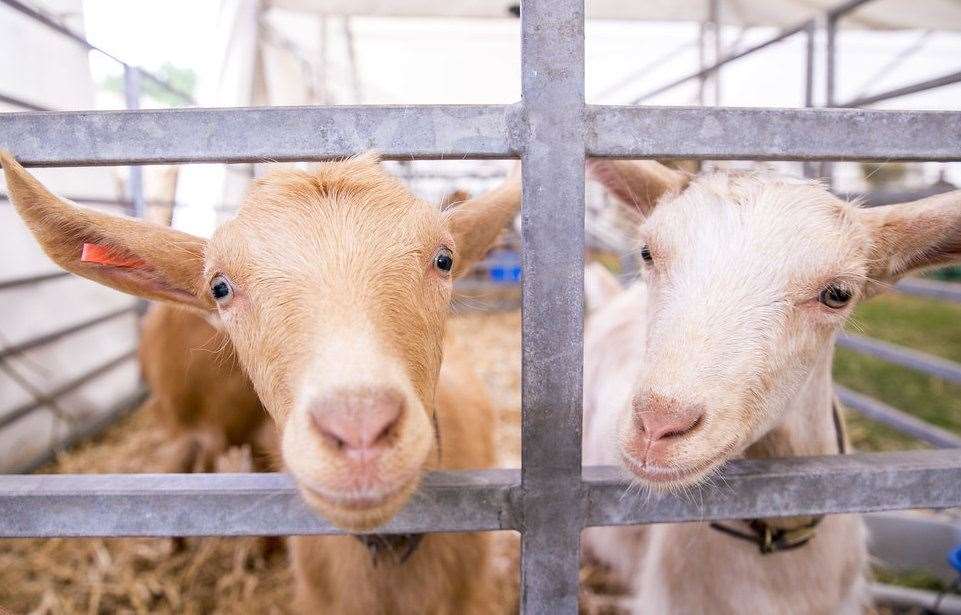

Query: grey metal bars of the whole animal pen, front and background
0,0,961,613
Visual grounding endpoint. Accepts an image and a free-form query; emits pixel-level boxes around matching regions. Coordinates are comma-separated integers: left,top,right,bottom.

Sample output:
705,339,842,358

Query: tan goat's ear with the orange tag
0,150,214,309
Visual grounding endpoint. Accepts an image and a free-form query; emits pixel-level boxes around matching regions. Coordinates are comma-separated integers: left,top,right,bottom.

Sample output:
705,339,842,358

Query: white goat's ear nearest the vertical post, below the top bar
587,158,690,216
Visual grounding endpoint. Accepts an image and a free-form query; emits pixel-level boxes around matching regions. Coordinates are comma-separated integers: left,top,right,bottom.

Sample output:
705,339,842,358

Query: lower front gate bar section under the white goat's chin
584,449,961,525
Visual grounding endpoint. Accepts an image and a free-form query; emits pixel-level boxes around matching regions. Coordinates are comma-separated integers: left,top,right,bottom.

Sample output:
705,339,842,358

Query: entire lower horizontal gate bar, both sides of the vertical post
0,449,961,538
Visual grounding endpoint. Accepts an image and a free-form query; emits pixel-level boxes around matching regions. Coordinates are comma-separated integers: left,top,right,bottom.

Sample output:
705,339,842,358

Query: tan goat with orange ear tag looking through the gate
0,154,520,614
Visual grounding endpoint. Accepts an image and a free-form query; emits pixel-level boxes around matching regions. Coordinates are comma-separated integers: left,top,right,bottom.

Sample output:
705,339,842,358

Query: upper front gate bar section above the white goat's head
588,106,961,161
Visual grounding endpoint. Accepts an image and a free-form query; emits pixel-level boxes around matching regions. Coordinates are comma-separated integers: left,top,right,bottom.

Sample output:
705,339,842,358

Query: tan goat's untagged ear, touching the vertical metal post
447,164,521,277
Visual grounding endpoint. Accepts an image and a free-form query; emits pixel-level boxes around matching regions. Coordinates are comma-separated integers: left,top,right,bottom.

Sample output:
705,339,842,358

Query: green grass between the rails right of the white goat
834,294,961,451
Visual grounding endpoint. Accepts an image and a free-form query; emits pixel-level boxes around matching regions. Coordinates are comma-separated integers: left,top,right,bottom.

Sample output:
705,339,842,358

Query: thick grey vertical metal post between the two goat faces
521,0,586,615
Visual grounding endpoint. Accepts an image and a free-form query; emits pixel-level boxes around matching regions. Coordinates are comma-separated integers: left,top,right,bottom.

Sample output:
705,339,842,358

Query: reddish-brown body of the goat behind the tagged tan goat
139,303,267,472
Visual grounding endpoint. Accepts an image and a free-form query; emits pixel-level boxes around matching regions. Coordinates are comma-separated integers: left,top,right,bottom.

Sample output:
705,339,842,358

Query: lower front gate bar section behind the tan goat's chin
0,470,520,537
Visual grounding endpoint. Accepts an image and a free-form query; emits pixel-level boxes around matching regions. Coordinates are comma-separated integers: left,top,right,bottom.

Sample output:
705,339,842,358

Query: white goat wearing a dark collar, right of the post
584,160,961,614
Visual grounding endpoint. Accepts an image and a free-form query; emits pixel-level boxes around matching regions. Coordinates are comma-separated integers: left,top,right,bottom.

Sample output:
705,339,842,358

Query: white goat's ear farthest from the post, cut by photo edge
860,190,961,282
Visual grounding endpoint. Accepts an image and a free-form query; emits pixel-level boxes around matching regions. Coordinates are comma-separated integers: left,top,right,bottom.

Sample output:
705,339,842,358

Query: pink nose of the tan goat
309,389,404,453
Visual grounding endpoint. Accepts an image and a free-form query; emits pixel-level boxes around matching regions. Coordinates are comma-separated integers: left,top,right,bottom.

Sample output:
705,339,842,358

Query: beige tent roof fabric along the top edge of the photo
269,0,961,30
